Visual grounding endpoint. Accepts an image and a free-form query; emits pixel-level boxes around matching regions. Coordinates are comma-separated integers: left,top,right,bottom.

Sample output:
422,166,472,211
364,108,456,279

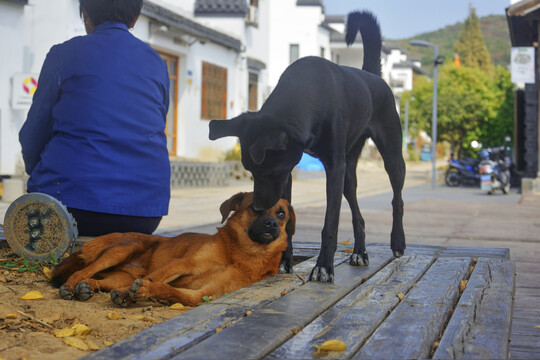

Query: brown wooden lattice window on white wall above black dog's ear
201,62,227,120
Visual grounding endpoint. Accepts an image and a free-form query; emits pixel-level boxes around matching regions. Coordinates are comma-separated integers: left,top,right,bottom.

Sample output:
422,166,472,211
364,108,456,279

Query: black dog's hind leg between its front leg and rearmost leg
343,145,369,266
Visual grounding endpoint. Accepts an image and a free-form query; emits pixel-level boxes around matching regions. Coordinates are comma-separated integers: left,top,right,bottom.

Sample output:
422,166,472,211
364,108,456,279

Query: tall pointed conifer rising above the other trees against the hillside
454,6,492,71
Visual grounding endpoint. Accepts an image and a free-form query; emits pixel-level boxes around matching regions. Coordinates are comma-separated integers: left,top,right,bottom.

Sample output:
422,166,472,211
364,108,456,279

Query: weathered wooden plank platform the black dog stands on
81,242,515,359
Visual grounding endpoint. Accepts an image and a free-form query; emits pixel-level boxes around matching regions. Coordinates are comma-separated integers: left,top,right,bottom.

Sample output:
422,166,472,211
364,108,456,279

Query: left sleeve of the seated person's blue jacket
19,46,60,174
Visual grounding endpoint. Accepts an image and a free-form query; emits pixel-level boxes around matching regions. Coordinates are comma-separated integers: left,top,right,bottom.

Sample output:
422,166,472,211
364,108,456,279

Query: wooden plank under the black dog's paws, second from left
167,253,392,359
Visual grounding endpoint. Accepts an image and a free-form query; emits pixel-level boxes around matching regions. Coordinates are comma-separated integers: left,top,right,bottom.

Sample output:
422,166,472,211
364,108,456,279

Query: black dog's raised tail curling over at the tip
345,11,382,76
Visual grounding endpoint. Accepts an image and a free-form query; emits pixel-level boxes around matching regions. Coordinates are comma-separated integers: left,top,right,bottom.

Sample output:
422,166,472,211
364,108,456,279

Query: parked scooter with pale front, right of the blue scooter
479,146,512,195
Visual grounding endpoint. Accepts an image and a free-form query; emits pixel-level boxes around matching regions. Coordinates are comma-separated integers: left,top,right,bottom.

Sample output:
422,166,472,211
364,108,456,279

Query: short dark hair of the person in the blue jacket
79,0,143,27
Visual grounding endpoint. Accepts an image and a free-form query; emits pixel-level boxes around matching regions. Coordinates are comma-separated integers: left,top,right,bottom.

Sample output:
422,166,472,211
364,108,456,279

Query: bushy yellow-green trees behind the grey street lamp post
402,64,513,156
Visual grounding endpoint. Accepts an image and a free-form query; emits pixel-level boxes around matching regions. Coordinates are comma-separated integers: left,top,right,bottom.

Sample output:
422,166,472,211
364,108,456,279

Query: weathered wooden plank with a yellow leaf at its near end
265,255,434,359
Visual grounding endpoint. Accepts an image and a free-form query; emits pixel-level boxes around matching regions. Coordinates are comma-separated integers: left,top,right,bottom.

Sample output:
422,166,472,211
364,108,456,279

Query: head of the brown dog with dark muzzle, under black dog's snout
219,193,296,251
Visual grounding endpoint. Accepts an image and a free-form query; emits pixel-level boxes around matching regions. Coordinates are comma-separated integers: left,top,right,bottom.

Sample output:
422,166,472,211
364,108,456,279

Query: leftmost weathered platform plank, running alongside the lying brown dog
81,253,349,359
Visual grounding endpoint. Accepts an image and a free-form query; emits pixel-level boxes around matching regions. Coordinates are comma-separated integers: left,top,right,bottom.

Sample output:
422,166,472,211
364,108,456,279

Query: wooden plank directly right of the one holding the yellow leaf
353,258,472,359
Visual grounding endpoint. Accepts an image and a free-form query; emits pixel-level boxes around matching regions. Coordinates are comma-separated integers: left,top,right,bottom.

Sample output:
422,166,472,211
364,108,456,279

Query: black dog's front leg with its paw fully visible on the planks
309,162,345,282
